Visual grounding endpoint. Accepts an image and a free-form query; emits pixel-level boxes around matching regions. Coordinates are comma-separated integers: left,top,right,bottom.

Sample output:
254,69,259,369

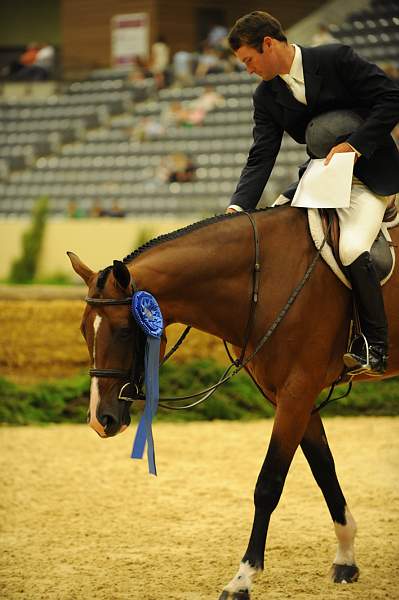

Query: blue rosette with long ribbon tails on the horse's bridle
131,291,163,475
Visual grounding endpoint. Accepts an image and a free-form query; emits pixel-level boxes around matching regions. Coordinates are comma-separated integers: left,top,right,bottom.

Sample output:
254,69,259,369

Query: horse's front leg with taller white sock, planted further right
301,413,359,583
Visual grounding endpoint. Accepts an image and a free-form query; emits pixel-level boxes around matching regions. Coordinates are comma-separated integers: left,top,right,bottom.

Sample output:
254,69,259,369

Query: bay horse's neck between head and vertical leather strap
129,217,254,336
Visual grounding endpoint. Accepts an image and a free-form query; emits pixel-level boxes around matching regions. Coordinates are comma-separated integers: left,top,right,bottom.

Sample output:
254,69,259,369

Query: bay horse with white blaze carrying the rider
68,207,399,600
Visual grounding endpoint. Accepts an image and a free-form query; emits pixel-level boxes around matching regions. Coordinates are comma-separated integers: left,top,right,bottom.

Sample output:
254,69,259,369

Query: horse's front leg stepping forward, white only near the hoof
219,395,312,600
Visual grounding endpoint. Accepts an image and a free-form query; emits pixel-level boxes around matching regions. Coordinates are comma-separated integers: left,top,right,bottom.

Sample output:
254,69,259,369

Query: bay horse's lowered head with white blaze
68,252,144,437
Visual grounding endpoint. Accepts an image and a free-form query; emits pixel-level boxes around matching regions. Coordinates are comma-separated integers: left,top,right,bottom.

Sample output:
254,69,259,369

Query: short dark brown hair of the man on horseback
228,10,287,52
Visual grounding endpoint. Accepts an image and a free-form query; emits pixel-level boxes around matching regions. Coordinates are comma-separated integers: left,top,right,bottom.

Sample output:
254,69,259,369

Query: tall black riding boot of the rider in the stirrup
344,252,388,375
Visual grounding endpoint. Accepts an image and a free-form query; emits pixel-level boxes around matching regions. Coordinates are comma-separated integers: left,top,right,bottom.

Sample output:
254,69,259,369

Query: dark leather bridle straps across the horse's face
85,296,145,402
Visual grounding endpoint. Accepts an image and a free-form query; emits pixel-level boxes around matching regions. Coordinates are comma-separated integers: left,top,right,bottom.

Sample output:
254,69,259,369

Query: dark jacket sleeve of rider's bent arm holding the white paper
336,45,399,158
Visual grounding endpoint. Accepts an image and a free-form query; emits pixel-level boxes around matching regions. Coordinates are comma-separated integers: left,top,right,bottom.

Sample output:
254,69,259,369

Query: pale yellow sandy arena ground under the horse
0,418,399,600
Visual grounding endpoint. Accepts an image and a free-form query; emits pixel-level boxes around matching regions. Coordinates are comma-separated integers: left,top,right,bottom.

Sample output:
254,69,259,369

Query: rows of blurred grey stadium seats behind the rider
0,0,399,217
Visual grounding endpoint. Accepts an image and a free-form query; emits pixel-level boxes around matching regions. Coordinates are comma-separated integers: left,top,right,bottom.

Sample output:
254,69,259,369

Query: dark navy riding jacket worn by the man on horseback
230,44,399,209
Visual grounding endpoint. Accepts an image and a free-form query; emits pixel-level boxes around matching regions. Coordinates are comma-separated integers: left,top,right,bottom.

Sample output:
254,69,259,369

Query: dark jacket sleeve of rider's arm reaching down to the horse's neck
230,90,283,210
